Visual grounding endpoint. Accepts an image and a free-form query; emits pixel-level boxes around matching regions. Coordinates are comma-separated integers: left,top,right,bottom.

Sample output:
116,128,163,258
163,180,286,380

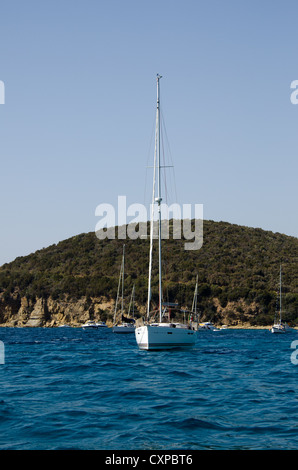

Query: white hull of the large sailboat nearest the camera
135,324,197,350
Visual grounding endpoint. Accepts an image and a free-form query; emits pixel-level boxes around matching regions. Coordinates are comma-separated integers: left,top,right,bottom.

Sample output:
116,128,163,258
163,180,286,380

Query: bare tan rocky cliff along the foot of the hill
0,295,266,327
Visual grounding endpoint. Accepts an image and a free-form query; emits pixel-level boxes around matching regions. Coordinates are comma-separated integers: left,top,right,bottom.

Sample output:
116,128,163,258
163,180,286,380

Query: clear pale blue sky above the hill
0,0,298,264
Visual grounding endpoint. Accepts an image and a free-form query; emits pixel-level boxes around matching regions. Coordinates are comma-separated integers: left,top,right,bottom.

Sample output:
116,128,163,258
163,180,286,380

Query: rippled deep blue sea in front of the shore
0,328,298,451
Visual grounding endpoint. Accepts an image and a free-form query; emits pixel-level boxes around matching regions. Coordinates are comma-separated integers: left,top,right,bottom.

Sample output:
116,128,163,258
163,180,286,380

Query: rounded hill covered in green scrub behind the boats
0,221,298,325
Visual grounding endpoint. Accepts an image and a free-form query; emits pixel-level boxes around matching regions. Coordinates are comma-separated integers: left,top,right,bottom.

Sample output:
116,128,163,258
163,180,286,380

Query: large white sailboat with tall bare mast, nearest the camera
135,75,196,350
